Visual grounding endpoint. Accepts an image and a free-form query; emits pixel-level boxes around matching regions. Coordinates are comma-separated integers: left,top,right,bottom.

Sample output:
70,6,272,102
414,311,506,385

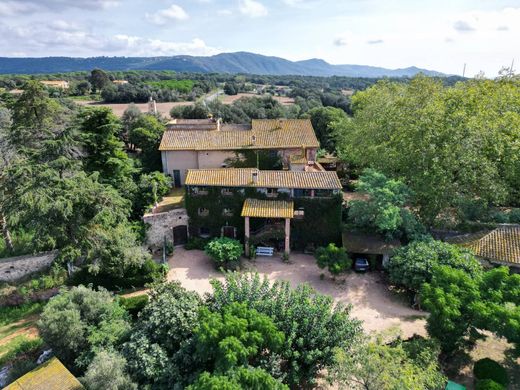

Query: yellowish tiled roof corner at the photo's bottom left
4,358,83,390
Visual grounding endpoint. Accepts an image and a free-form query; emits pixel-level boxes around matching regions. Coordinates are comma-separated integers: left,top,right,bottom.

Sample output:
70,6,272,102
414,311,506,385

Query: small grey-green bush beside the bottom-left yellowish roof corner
81,350,137,390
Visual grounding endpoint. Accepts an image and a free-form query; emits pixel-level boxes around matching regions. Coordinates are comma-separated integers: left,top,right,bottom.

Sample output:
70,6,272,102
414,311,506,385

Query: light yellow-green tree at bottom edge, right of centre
330,340,446,390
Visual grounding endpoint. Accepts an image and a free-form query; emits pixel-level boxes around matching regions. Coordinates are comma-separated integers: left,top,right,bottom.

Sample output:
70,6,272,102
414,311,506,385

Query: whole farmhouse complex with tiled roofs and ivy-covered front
145,119,343,253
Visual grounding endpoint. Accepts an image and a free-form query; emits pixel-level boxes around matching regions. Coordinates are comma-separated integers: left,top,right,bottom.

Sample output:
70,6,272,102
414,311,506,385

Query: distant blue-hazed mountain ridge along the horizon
0,52,446,77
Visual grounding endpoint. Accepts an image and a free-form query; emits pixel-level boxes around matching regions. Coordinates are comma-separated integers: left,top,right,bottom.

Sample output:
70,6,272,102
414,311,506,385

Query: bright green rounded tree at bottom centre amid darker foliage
194,302,285,373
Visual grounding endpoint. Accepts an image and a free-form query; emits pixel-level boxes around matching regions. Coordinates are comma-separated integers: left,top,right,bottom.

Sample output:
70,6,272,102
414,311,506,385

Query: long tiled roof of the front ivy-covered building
186,168,342,190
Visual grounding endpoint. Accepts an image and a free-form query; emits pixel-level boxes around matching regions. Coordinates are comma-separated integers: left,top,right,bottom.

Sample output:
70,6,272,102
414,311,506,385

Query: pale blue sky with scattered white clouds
0,0,520,76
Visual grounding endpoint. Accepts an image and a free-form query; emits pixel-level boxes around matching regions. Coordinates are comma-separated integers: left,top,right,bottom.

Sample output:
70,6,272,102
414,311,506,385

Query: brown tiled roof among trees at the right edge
447,225,520,265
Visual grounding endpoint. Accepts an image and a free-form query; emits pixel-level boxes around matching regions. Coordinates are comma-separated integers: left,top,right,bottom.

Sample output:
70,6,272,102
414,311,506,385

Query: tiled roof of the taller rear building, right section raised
159,119,319,151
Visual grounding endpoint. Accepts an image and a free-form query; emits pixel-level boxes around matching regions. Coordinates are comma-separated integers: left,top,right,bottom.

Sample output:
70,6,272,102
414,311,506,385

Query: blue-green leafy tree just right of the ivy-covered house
348,169,425,239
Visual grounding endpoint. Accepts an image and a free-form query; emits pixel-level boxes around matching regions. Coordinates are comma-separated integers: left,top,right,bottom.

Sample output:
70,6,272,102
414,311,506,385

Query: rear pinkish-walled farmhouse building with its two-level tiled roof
159,119,319,187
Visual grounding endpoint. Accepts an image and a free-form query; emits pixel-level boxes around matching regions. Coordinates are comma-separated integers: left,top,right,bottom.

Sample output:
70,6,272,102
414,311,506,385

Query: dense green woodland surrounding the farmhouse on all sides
0,71,520,390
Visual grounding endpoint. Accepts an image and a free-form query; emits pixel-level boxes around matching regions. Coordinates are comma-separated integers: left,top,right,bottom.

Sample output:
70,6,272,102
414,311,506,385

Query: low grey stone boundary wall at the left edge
0,251,58,283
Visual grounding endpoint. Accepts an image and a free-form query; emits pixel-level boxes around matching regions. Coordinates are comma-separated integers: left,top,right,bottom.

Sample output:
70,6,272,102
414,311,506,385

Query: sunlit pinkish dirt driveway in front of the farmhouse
168,248,426,337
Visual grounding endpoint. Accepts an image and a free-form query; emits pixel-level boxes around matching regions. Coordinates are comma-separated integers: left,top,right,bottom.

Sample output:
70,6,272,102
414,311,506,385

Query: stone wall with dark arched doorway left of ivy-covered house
143,209,188,248
